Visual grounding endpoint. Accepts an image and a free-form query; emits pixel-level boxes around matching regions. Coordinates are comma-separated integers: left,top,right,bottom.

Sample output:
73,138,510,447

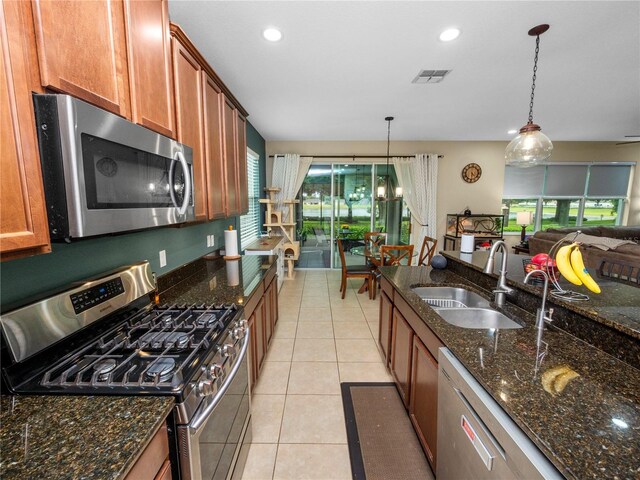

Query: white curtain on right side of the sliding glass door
393,153,438,253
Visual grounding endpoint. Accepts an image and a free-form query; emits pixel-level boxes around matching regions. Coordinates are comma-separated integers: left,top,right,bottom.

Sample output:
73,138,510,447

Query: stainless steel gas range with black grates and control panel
0,262,251,480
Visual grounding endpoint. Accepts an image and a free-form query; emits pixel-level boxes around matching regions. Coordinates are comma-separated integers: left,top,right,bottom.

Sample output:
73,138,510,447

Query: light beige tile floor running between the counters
242,270,392,480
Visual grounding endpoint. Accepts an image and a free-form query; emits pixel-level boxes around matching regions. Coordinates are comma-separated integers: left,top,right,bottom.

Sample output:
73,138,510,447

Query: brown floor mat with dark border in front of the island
341,383,434,480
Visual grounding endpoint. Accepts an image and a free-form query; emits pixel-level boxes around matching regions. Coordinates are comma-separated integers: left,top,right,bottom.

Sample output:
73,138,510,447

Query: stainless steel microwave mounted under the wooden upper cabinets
33,94,195,241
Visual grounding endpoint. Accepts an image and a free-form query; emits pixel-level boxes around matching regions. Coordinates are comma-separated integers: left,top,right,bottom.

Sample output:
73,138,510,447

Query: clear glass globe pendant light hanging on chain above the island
505,24,553,167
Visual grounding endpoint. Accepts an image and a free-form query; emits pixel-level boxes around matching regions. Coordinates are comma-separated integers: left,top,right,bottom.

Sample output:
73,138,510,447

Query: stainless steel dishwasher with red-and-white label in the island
437,347,563,480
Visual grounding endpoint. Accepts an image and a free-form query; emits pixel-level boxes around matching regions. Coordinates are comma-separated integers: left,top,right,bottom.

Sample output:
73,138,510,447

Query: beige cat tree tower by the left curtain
260,187,300,278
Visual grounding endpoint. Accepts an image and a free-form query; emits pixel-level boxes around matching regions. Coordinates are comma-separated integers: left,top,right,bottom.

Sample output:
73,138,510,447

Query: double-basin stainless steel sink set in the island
412,287,522,329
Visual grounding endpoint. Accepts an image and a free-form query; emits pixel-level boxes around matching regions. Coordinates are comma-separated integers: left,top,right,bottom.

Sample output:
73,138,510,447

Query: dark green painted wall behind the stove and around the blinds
0,119,265,310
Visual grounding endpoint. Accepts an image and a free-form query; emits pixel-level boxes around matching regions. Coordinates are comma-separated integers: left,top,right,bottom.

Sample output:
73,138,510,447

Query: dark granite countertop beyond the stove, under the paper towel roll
158,255,277,305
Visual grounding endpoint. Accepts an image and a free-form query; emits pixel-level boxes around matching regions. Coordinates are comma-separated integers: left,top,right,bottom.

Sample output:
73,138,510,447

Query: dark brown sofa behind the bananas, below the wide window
529,225,640,269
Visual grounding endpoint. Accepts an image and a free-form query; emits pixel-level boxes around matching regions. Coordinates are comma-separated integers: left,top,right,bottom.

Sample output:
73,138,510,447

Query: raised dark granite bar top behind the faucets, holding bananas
442,251,640,340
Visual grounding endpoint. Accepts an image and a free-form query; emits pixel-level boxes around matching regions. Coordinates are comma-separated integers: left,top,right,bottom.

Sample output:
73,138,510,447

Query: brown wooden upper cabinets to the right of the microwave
170,23,249,220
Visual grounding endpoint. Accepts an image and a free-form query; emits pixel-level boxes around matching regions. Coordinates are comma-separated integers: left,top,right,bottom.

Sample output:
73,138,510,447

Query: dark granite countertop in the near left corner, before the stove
0,395,175,480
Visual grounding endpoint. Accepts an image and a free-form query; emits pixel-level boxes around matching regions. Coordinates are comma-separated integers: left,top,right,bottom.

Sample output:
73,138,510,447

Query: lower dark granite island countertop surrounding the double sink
380,267,640,479
